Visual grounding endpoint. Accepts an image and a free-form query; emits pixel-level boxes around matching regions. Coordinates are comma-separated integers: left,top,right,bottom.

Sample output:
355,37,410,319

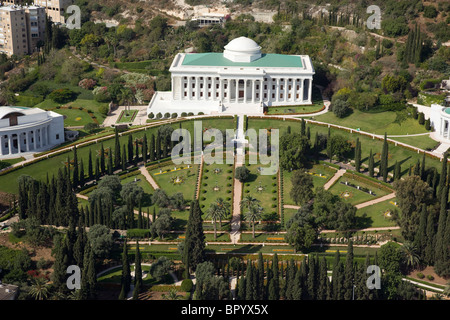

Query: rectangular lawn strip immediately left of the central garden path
199,163,234,213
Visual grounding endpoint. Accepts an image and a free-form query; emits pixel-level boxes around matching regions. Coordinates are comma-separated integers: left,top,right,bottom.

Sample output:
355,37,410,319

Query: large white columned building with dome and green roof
147,37,315,115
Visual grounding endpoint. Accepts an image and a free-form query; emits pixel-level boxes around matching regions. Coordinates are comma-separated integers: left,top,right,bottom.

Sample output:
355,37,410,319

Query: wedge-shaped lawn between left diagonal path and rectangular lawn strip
149,164,199,200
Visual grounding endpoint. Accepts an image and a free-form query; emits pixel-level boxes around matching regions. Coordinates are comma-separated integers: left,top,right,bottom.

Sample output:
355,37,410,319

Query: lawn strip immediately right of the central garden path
242,163,278,220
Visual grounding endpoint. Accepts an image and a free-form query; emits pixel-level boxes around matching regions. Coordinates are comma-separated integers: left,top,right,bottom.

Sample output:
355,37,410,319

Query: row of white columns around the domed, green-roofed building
176,76,312,103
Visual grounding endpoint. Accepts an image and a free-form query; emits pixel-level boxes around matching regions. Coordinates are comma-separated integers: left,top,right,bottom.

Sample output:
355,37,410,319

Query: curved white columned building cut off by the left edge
0,107,64,159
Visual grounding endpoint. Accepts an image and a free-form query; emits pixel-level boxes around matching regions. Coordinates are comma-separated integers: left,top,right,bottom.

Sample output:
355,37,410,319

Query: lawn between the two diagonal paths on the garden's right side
329,175,388,205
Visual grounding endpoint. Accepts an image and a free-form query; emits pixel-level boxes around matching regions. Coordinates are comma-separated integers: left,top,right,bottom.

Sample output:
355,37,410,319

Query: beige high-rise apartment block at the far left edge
0,5,45,56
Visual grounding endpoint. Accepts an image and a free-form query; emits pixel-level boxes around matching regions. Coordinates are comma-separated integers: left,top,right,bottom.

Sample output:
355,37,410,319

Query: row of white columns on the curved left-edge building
0,125,50,156
